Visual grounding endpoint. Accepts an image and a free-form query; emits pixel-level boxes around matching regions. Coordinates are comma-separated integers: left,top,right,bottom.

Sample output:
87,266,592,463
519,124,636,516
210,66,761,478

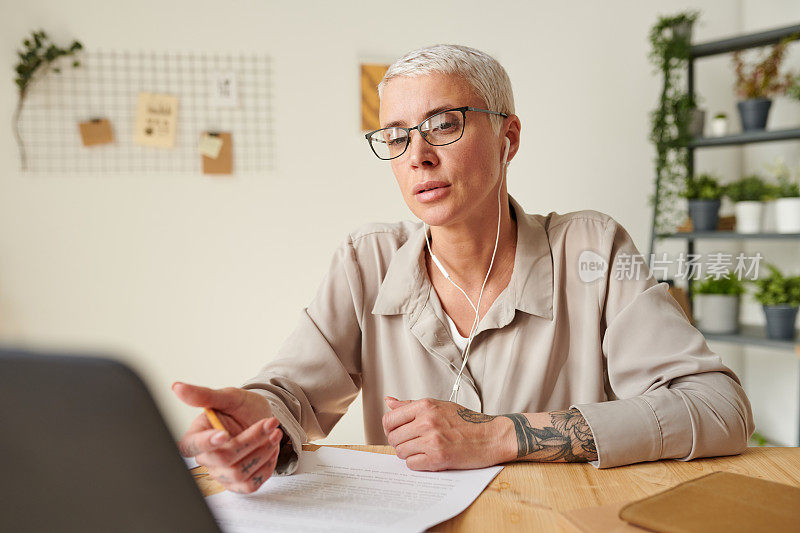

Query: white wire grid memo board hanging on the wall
20,50,274,174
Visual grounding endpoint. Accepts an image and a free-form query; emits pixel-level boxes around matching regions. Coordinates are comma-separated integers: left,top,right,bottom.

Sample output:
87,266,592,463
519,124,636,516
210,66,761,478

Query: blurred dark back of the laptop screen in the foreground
0,348,219,533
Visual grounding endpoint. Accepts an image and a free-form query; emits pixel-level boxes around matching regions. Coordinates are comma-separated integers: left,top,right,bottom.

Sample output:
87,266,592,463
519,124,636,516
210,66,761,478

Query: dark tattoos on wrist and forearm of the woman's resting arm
458,408,597,463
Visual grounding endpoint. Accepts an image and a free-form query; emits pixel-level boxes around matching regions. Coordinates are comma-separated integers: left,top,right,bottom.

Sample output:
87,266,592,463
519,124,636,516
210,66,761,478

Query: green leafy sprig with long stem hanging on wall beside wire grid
12,30,83,170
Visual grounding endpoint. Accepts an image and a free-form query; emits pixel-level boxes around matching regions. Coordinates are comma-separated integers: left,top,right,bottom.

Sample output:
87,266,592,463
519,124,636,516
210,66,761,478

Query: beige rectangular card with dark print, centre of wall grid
133,93,178,148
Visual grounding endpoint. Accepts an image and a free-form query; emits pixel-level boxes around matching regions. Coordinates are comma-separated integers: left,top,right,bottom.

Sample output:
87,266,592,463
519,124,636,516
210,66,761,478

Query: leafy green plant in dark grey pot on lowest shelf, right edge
751,263,800,340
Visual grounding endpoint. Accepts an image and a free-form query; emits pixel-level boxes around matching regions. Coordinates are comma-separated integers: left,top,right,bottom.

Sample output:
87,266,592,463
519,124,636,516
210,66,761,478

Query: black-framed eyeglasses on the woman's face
365,106,508,160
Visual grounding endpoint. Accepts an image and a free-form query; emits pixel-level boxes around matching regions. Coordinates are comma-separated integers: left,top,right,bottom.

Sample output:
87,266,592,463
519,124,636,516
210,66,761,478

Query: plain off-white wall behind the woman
0,0,800,442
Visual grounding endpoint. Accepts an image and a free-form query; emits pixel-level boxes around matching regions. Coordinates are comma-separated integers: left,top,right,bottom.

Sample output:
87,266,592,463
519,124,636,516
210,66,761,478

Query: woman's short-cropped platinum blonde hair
378,44,514,133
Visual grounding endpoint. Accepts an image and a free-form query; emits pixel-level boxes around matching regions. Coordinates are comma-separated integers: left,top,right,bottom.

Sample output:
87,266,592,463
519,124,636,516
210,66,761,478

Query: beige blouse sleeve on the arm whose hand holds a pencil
242,234,363,475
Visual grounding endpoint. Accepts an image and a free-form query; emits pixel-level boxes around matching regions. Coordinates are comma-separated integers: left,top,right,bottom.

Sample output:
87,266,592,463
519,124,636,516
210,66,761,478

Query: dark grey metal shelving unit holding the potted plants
650,24,800,356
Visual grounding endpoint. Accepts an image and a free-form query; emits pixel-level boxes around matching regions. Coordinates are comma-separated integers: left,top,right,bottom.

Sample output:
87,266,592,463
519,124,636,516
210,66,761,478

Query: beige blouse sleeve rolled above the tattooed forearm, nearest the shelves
571,219,755,468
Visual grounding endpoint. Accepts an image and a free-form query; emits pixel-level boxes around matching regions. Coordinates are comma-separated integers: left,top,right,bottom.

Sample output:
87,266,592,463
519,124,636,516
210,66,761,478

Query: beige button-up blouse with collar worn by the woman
243,193,754,474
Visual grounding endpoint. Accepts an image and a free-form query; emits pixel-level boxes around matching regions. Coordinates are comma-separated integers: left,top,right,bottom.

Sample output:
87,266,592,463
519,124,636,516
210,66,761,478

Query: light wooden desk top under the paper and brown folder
193,445,800,533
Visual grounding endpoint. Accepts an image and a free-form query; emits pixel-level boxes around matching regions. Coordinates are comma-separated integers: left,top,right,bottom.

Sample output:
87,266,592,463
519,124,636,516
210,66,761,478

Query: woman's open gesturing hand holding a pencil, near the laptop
172,382,283,494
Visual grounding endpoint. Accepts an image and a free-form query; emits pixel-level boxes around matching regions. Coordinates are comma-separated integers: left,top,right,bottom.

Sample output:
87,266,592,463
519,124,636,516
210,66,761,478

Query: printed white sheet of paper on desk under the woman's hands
206,448,503,533
